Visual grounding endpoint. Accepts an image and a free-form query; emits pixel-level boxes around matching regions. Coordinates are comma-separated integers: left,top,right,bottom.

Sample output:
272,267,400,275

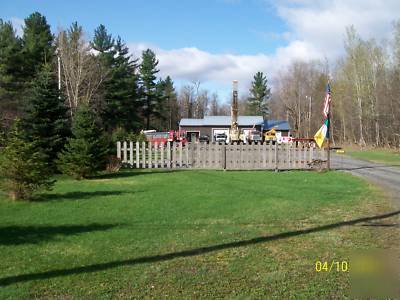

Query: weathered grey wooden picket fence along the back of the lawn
117,142,327,170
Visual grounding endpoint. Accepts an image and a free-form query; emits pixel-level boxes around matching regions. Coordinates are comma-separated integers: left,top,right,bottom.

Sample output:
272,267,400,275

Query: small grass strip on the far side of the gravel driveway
346,149,400,166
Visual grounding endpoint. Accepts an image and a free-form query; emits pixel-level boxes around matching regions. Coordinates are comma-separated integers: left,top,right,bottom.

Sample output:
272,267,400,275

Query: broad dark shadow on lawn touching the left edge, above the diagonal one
0,224,118,246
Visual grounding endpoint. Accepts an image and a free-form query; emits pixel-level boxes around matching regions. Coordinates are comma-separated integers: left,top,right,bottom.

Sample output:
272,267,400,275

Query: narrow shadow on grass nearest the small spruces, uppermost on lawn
33,191,129,202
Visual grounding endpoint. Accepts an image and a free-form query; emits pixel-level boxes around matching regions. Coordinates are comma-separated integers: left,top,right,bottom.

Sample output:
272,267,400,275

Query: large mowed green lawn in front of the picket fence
0,170,398,299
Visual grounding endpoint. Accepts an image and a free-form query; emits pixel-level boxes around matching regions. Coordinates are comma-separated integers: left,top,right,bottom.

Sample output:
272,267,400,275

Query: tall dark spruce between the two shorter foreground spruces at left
22,64,69,165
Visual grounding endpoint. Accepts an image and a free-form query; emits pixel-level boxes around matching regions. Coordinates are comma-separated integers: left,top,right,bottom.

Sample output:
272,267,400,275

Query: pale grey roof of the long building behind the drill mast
179,116,264,126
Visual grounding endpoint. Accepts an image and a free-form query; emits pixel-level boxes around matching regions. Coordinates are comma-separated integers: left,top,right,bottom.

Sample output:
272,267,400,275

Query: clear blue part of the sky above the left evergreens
0,0,287,54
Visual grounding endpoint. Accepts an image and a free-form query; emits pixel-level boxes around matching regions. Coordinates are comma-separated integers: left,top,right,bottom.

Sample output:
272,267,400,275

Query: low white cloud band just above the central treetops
129,41,322,86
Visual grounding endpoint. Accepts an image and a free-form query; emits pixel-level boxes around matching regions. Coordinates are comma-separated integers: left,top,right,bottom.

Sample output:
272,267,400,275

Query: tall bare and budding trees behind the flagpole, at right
270,22,400,148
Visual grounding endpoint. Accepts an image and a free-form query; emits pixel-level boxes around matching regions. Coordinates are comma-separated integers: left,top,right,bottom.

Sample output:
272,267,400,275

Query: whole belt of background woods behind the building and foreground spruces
0,12,400,148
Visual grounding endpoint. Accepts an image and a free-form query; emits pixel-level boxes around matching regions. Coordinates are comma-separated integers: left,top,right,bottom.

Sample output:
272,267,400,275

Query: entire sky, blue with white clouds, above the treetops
0,0,400,101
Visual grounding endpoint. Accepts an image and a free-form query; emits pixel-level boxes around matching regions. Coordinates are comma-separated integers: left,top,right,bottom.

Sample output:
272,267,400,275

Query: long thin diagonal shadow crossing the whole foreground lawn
0,210,400,286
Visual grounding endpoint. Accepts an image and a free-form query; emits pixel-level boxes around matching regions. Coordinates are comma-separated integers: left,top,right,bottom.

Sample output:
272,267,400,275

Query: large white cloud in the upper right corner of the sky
268,0,400,58
